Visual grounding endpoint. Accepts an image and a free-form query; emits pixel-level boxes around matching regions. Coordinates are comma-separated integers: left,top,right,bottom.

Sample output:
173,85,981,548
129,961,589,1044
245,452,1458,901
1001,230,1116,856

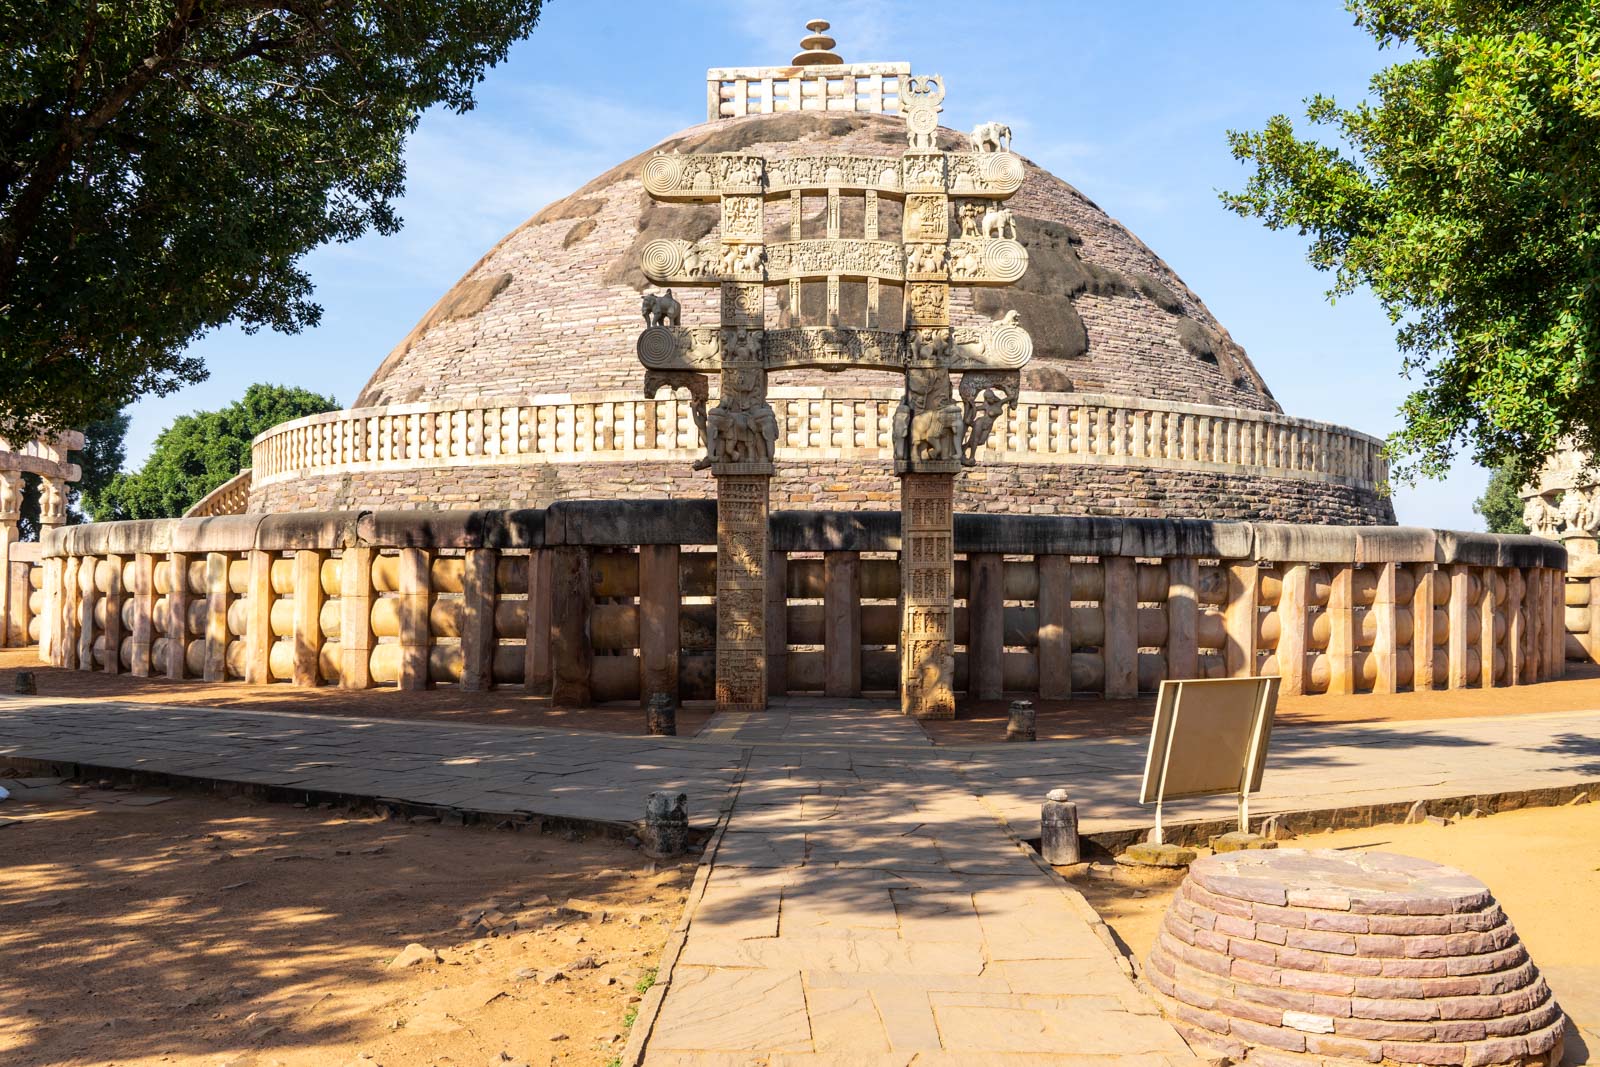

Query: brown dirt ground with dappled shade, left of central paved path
0,777,693,1067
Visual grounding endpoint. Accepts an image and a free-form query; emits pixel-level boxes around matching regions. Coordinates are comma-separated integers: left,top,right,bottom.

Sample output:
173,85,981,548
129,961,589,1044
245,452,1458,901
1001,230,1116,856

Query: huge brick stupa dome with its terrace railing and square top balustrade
233,38,1394,523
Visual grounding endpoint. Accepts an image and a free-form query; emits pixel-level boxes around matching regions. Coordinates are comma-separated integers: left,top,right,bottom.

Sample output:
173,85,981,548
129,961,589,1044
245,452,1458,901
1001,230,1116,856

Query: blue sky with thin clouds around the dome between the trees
128,0,1486,530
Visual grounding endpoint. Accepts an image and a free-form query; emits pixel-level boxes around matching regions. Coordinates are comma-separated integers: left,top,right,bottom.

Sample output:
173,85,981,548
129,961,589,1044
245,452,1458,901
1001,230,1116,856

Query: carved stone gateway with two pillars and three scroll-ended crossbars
638,37,1034,718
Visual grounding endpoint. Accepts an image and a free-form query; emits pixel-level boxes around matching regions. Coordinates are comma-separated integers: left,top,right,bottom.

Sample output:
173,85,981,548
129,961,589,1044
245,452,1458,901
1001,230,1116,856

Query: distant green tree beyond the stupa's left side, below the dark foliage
86,384,339,522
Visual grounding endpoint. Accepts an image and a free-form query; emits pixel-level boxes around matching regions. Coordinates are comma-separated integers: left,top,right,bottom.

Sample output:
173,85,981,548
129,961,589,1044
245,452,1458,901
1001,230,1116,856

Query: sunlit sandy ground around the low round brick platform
1072,803,1600,1064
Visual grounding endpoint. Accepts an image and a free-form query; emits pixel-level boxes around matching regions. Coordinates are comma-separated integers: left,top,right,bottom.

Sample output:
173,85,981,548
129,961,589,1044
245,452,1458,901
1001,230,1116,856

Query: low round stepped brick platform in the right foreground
1146,849,1565,1067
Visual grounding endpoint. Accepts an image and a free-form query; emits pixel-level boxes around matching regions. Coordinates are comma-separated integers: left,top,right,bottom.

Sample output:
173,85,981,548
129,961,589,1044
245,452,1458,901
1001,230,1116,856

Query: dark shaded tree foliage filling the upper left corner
0,0,539,440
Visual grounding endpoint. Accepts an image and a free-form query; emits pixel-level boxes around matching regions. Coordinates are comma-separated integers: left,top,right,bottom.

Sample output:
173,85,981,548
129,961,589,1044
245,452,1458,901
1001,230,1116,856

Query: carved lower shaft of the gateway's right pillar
901,474,955,718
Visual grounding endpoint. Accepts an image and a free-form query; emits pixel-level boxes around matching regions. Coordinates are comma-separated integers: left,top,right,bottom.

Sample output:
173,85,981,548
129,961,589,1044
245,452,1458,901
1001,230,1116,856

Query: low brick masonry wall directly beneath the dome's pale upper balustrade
250,461,1395,525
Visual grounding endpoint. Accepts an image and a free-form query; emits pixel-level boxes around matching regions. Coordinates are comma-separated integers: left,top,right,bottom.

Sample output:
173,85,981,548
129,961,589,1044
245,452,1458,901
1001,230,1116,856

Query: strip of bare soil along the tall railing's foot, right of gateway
923,664,1600,744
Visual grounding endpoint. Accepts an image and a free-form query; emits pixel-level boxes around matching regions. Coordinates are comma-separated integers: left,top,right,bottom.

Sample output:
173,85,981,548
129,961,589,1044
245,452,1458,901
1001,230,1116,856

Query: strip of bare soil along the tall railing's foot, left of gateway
0,648,715,737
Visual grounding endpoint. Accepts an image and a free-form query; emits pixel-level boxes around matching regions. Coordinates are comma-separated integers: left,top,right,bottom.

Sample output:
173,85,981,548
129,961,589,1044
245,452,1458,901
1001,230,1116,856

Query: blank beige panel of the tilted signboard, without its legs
1139,678,1278,805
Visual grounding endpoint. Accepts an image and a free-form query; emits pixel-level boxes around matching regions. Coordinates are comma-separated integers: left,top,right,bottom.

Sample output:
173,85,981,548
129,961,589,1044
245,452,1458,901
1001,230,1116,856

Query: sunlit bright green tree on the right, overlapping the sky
1222,0,1600,483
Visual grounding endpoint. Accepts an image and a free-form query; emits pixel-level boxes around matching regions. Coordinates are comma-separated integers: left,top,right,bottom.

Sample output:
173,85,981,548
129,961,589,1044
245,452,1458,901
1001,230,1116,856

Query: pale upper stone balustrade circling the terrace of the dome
253,387,1387,490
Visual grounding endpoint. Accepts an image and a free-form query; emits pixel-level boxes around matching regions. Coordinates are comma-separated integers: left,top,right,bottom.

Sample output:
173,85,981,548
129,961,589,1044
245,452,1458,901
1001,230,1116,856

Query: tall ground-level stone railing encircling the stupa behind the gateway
32,501,1566,705
